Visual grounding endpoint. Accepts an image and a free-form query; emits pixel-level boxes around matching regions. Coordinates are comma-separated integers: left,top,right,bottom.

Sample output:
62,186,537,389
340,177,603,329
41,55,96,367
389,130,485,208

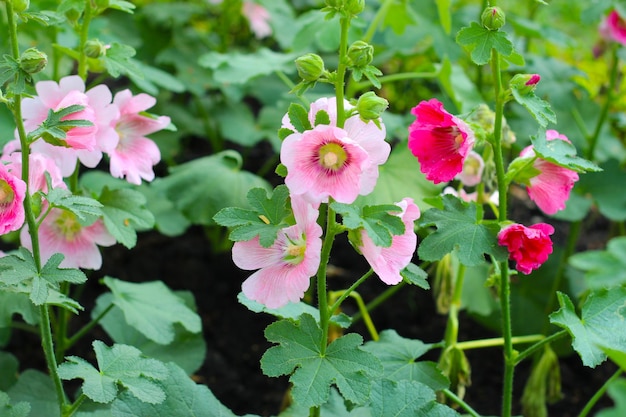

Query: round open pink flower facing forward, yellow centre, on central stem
280,125,373,204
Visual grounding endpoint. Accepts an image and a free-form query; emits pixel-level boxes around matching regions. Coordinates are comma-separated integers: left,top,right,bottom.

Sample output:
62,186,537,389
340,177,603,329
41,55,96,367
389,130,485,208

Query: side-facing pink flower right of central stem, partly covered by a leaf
359,198,420,285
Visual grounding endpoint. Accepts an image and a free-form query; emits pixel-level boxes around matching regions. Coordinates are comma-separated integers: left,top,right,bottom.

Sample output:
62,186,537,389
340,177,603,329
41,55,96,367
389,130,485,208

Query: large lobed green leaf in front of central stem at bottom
261,314,382,407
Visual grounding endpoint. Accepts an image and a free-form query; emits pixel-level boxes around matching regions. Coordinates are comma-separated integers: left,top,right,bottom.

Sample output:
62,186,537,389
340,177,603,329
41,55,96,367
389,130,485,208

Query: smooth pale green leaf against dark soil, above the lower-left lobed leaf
104,277,202,345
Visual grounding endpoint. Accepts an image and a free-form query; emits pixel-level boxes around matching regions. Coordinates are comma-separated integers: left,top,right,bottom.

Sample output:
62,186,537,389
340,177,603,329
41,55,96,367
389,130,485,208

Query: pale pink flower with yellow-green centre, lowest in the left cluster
20,208,115,270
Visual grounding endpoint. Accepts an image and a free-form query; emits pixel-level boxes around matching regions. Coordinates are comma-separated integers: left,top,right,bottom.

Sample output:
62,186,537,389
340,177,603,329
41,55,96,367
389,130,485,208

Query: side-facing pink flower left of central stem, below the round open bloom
233,196,322,308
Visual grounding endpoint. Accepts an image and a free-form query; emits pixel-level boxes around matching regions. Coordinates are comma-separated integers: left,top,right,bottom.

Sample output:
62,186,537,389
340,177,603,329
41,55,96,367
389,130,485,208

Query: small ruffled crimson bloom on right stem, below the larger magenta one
498,223,554,274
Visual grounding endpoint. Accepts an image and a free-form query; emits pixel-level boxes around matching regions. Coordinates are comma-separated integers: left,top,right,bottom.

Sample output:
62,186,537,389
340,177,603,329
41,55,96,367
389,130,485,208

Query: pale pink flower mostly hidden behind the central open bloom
282,97,391,195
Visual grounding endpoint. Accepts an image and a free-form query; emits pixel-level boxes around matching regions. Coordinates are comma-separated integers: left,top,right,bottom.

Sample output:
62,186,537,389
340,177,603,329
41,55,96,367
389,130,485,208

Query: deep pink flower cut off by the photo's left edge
0,163,26,235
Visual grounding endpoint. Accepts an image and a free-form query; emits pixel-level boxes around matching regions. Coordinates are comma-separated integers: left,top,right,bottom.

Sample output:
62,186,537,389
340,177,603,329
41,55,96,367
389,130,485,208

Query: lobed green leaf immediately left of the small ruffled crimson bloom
417,195,508,266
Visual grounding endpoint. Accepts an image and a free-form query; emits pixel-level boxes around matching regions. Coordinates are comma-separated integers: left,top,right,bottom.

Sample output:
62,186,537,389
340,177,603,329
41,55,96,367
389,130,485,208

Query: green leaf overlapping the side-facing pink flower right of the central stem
331,202,404,248
